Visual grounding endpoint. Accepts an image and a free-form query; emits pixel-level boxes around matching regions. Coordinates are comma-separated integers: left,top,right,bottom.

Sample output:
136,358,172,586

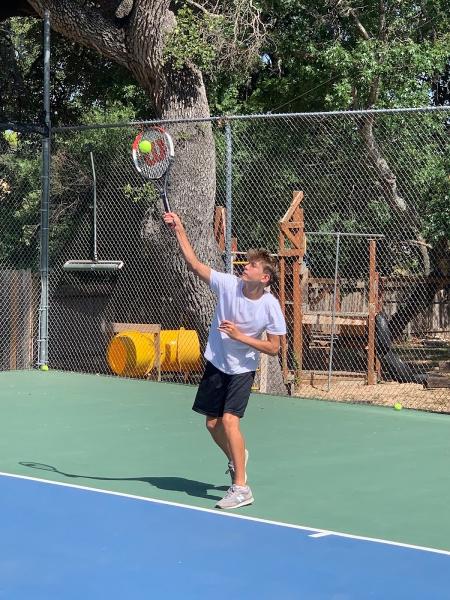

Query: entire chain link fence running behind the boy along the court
0,110,450,411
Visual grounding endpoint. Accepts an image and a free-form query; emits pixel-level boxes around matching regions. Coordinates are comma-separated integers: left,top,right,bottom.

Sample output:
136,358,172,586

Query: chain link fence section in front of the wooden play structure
225,110,450,411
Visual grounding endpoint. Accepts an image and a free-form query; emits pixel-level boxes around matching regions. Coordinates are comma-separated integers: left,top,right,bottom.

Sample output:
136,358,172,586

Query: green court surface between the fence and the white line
0,371,450,550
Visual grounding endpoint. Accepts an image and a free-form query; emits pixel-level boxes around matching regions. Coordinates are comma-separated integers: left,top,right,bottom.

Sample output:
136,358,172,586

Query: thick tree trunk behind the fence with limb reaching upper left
24,0,220,341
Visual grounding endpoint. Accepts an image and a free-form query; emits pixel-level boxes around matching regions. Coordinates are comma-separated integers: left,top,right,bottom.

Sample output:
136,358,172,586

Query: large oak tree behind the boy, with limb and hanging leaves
0,0,284,391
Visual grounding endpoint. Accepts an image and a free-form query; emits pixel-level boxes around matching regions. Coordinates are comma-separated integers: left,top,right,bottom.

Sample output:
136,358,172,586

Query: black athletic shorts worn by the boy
192,362,255,418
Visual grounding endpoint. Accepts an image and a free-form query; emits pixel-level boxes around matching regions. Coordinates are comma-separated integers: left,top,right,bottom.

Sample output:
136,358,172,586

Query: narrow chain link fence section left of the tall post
0,130,41,370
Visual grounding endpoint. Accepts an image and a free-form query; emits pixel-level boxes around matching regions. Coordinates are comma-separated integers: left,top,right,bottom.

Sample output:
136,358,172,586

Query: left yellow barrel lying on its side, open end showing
106,331,155,377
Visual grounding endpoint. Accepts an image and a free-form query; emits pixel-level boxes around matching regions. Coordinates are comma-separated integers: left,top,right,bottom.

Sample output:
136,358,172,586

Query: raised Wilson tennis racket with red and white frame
132,127,175,212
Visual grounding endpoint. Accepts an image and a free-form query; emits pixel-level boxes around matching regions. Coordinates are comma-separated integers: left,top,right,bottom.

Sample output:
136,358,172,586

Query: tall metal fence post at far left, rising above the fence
38,10,51,366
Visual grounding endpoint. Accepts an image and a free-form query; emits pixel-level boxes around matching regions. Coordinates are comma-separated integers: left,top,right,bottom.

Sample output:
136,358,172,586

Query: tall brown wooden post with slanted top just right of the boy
278,191,305,386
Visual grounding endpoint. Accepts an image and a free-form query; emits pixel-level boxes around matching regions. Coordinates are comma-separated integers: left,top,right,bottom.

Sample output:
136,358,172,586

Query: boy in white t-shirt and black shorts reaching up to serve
164,212,286,509
